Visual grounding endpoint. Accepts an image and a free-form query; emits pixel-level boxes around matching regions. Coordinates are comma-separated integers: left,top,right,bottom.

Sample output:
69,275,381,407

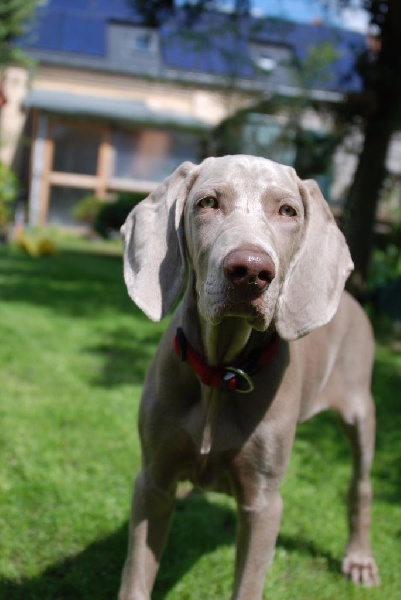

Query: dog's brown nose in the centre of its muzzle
223,246,276,291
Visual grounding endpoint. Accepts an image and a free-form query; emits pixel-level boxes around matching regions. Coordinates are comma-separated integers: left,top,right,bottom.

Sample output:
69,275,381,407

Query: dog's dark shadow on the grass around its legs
0,494,340,600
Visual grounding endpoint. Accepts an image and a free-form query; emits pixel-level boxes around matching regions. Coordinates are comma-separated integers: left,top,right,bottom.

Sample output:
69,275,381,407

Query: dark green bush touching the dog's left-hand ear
93,192,147,239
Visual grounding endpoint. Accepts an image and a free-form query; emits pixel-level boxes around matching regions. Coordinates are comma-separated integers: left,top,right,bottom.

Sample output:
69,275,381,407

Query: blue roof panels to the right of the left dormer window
160,13,363,91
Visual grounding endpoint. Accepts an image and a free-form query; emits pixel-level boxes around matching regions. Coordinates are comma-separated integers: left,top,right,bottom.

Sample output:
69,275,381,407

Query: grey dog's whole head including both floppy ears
122,155,353,340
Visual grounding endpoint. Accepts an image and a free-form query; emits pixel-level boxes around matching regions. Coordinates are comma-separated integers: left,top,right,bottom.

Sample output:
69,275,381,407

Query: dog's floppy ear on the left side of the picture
121,162,196,321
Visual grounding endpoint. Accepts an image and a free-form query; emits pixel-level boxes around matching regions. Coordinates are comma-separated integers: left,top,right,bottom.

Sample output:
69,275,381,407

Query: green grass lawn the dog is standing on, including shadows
0,232,401,600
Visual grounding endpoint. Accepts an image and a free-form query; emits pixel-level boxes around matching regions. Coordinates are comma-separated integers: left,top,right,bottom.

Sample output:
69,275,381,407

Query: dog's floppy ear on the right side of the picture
276,180,354,340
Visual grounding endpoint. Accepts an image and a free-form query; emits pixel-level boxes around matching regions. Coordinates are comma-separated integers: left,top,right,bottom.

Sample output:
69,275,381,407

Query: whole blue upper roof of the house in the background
20,0,363,92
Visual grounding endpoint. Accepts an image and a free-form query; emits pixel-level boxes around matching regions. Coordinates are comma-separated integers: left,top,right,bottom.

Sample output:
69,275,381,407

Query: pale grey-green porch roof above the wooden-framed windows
23,89,211,130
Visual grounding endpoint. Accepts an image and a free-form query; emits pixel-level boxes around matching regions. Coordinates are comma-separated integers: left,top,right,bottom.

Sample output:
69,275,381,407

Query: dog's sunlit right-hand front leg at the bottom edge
232,491,282,600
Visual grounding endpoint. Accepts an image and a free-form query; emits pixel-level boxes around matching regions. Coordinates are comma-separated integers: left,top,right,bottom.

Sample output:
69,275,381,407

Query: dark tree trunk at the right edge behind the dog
343,0,401,295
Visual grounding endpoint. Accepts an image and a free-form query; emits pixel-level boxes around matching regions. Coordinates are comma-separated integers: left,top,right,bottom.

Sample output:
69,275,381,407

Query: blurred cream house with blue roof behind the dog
0,0,363,225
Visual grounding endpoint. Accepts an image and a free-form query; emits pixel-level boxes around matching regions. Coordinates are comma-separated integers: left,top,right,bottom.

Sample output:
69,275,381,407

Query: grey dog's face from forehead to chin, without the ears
185,156,305,329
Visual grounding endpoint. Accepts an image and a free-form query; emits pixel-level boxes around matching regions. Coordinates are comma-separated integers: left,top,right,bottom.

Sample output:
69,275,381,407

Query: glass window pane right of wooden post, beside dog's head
112,129,199,181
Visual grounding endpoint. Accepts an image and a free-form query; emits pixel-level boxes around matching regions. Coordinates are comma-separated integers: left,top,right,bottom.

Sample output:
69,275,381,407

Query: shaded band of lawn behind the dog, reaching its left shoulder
0,249,165,387
